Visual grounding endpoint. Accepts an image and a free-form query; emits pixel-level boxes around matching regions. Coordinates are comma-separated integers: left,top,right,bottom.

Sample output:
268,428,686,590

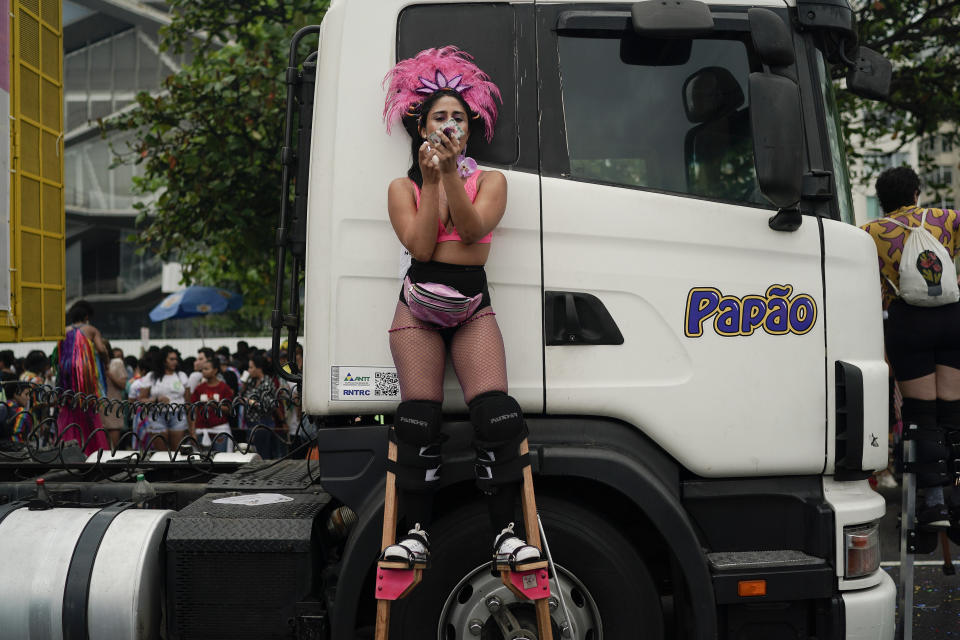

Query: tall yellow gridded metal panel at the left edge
0,0,65,342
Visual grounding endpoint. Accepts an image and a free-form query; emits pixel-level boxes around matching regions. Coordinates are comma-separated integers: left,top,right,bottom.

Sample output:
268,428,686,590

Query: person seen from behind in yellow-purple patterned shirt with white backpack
862,167,960,537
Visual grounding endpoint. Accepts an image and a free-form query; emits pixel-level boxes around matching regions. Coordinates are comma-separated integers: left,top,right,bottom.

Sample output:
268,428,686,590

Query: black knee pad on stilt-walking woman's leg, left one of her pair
388,400,443,492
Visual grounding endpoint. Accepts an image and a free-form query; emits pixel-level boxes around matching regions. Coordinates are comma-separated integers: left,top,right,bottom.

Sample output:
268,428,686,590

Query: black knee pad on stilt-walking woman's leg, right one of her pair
469,391,529,493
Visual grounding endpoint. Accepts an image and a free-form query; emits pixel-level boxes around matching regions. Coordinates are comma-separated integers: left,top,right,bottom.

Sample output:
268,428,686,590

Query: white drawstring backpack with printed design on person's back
884,209,960,307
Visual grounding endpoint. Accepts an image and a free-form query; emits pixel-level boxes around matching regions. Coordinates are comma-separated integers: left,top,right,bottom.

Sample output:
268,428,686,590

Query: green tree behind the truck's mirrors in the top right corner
835,0,960,199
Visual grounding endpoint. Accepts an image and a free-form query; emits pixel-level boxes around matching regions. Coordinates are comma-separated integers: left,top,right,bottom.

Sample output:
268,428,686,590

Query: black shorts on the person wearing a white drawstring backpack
883,300,960,380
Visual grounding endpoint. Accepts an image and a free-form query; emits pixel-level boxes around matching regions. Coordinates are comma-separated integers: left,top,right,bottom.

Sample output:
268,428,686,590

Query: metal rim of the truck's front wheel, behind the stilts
437,562,603,640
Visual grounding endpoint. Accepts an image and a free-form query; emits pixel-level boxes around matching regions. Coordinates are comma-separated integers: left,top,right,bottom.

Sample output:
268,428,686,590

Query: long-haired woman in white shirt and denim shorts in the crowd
140,345,188,451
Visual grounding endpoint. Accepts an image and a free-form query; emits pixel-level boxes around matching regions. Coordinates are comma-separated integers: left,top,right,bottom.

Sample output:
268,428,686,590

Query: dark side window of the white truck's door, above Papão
559,31,771,207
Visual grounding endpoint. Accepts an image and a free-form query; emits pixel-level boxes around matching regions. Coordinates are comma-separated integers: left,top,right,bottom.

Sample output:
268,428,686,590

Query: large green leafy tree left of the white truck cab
102,0,329,331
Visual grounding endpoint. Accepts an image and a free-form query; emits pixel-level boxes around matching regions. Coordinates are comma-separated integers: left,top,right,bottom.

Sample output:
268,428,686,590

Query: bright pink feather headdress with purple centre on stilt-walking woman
383,45,503,142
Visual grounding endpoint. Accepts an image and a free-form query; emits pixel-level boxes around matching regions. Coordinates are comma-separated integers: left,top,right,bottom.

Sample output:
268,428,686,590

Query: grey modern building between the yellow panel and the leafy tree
63,0,186,338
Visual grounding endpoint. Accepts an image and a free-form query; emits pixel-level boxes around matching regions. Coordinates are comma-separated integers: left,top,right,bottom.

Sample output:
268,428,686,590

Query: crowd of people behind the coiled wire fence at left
0,301,312,459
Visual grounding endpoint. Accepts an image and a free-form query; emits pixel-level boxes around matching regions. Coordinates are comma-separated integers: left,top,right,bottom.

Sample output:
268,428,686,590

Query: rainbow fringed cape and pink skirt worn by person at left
53,326,110,455
